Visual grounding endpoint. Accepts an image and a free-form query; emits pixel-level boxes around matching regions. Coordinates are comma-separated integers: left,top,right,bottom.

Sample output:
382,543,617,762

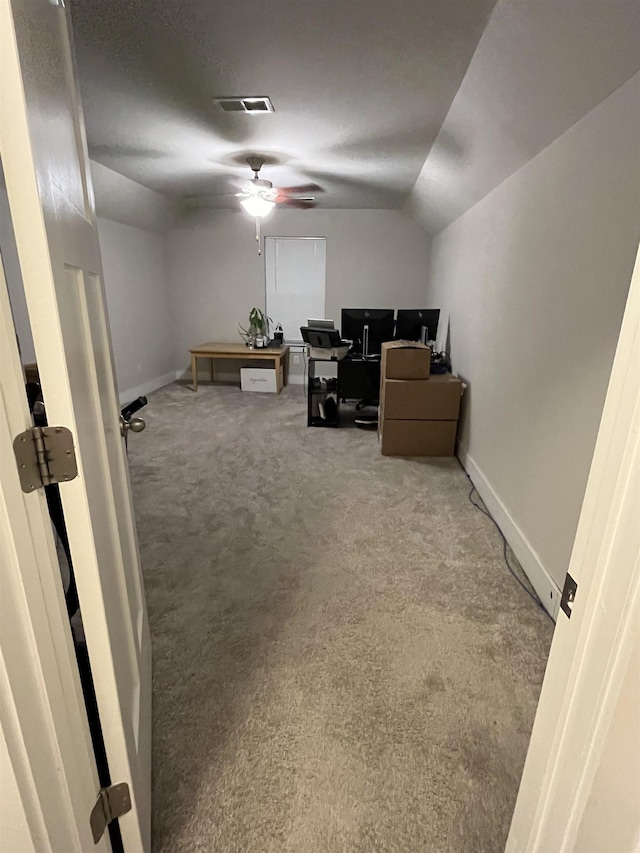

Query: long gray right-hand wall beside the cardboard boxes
429,75,640,586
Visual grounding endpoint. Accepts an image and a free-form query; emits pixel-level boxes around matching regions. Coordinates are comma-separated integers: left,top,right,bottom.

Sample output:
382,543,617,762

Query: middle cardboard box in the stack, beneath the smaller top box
380,373,462,421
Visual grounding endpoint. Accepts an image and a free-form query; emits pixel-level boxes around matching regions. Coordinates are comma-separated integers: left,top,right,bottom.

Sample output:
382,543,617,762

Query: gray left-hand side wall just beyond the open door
98,219,175,402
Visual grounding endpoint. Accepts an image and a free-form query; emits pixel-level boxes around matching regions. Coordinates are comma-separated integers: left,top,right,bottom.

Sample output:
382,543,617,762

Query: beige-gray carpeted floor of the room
129,384,553,853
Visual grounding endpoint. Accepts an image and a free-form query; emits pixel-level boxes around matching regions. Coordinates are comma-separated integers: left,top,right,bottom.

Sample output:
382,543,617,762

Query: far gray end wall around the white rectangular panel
167,210,429,380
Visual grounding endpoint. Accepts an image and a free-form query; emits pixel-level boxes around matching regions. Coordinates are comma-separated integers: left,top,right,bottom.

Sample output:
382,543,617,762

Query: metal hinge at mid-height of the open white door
13,427,78,492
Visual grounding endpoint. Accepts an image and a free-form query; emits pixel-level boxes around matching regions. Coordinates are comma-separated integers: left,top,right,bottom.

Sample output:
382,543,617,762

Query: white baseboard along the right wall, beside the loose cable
458,442,561,622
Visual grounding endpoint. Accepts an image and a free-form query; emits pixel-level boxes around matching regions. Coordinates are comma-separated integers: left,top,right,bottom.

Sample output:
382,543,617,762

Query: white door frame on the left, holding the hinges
0,256,111,853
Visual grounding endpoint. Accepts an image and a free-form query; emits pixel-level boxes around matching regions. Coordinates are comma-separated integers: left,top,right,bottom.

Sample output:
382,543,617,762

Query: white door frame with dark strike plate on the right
506,243,640,853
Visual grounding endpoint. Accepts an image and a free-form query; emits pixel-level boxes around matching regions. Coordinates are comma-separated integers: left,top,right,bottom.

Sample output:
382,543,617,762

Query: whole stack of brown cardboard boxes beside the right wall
378,341,462,456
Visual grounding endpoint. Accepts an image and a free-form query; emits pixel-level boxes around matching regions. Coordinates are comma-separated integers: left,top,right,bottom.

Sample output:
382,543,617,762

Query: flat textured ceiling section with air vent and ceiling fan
71,0,495,208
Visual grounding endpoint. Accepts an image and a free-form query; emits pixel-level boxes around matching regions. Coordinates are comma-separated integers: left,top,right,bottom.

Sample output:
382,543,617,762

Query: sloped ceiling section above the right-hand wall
405,0,640,234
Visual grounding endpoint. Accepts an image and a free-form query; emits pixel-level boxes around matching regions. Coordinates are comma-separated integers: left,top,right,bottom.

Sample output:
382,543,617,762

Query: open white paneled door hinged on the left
0,0,151,853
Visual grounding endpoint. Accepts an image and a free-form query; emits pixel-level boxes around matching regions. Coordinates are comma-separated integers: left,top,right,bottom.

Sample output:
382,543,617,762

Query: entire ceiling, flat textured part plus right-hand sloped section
71,0,640,233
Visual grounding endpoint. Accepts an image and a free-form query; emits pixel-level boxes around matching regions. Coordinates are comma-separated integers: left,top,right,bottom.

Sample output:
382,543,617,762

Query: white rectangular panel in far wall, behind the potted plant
264,237,327,341
